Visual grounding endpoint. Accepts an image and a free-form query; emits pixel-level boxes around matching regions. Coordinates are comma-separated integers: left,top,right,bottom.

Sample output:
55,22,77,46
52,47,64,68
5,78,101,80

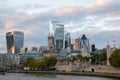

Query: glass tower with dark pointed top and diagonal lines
80,34,91,56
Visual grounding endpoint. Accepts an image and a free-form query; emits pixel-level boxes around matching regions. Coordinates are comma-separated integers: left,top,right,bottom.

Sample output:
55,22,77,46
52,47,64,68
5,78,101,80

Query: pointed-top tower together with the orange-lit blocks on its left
73,34,92,56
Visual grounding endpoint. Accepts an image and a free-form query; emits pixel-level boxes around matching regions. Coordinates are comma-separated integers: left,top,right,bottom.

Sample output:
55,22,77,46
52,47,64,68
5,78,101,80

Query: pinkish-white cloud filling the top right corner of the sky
86,0,120,15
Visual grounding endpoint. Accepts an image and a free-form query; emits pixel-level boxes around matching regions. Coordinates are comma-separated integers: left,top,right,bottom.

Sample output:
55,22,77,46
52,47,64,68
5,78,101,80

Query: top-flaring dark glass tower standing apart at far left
6,31,24,54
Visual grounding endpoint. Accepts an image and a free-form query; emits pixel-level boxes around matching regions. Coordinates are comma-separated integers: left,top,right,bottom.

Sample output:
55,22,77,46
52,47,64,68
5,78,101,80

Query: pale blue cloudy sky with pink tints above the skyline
0,0,120,52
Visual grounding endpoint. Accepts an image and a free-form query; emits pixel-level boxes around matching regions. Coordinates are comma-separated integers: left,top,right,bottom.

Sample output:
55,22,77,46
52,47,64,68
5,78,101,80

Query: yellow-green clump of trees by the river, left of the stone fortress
23,57,57,70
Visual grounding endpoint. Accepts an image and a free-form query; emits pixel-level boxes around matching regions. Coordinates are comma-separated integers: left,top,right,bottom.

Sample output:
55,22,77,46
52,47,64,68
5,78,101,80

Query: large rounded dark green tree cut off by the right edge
109,49,120,68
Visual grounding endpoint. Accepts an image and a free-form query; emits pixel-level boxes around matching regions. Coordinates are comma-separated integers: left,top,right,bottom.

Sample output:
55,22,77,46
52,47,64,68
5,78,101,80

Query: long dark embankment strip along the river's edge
7,71,120,79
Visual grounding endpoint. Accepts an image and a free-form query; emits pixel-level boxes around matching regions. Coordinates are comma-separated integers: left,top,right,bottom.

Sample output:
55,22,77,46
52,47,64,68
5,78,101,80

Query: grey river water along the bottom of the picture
0,73,119,80
